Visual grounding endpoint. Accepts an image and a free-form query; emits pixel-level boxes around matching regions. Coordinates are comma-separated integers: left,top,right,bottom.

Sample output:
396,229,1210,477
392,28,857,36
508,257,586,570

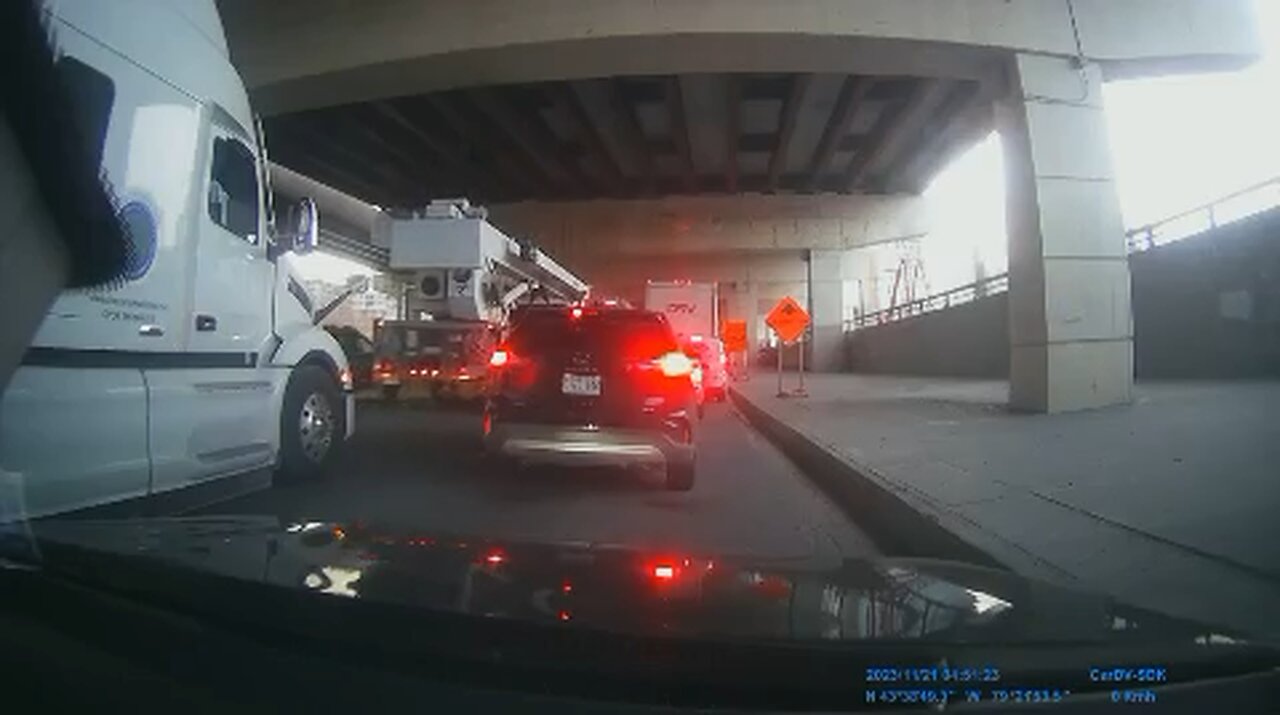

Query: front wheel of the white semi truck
280,365,347,480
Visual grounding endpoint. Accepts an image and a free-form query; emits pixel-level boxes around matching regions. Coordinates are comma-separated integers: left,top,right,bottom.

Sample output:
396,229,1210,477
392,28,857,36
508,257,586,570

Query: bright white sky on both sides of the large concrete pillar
922,0,1280,292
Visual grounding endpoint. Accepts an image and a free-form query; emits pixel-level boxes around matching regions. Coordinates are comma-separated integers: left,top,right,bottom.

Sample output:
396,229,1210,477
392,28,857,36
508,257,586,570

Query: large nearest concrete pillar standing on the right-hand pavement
996,55,1133,412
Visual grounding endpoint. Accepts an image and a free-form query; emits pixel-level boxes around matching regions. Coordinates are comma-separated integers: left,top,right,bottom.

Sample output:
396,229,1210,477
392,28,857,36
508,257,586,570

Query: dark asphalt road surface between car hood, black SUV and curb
202,402,874,568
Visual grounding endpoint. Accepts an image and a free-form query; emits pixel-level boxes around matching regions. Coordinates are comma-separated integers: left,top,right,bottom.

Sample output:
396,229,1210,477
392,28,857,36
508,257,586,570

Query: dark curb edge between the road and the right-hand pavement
728,386,1009,569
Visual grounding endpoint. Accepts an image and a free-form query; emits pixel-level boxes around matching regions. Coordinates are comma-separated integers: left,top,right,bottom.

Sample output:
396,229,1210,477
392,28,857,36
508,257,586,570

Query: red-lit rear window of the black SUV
508,310,676,358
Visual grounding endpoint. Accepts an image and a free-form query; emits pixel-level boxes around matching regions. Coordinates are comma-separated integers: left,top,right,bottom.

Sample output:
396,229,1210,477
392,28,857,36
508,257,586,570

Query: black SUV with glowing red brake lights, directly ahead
484,306,698,491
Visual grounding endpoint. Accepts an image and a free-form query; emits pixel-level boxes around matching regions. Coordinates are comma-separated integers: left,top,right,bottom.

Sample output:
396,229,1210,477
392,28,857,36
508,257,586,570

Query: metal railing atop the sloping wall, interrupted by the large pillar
845,177,1280,333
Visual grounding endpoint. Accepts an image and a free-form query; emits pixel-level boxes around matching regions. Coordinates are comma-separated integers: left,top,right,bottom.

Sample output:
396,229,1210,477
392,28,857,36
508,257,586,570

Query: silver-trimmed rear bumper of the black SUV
485,422,694,467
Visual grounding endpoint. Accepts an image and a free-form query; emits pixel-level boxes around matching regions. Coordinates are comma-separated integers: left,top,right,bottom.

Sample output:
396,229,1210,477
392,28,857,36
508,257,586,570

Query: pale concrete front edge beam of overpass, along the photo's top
219,0,1261,114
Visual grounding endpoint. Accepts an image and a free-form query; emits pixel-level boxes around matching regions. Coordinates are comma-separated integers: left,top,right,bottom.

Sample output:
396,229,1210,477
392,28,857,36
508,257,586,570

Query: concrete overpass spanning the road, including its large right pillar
238,0,1258,411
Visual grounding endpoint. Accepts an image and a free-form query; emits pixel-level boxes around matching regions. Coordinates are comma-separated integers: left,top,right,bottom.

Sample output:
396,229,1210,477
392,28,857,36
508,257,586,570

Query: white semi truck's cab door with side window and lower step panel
146,110,275,491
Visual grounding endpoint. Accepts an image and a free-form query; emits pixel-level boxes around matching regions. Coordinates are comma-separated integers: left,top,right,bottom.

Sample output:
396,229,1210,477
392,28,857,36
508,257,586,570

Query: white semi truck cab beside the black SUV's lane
0,0,355,521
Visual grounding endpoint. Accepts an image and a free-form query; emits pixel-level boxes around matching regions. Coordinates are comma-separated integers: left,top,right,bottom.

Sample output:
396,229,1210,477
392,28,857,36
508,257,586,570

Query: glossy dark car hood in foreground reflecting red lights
36,517,1235,643
